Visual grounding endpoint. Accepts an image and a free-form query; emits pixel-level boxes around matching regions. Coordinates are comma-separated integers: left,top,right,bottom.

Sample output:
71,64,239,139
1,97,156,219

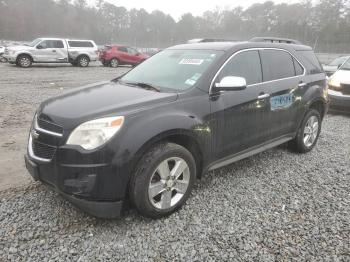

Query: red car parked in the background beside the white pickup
100,45,149,67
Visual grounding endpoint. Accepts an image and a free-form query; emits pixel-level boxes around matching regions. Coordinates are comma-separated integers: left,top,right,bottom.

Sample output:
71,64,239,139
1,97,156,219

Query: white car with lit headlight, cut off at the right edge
328,57,350,113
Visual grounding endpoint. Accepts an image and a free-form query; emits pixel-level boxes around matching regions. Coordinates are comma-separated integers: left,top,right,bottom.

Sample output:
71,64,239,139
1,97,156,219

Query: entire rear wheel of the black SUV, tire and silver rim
289,109,322,153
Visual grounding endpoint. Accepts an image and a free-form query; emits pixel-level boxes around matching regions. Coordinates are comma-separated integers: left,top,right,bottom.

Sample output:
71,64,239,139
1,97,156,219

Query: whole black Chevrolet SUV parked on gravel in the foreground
25,39,328,218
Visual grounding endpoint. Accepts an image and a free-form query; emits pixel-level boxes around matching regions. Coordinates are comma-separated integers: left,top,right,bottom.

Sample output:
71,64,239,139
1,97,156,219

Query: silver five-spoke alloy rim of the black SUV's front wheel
148,157,190,210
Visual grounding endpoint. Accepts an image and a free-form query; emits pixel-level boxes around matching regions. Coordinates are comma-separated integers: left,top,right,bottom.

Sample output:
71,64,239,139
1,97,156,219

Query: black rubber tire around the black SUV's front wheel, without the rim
131,143,196,218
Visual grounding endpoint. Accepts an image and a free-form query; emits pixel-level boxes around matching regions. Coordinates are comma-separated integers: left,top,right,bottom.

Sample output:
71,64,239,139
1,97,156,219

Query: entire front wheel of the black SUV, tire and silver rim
129,143,196,218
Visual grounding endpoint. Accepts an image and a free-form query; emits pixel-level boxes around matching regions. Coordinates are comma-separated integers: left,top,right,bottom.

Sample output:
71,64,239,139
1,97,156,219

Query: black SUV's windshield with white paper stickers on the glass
119,50,224,92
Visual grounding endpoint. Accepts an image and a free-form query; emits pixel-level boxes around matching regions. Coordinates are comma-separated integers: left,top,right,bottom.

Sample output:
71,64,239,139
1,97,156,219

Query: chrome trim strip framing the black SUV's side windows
209,47,306,94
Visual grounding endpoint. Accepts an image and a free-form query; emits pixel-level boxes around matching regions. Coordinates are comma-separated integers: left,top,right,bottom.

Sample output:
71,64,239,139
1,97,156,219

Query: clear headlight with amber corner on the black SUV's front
67,116,124,150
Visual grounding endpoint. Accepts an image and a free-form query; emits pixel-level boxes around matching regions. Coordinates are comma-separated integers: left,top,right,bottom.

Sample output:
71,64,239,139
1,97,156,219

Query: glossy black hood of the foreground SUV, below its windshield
38,81,178,127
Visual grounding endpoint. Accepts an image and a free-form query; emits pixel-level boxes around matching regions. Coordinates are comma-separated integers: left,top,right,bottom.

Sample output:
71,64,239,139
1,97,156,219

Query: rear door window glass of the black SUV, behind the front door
261,50,295,81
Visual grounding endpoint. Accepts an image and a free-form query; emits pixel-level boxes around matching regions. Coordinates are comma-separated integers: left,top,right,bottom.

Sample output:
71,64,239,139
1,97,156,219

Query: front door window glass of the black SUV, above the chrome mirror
217,51,262,85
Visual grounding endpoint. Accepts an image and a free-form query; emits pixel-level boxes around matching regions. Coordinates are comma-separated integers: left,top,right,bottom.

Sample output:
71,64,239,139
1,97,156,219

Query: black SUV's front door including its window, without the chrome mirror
210,50,269,161
